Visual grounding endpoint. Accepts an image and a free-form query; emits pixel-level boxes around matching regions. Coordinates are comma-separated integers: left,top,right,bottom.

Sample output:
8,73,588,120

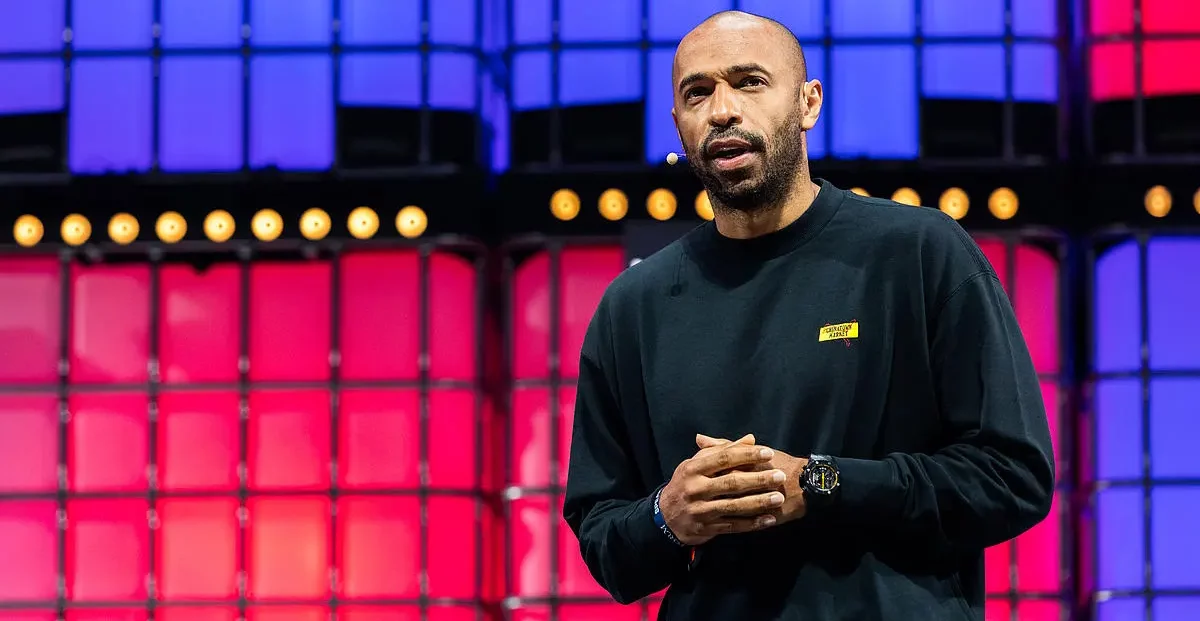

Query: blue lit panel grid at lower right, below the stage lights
1091,235,1200,621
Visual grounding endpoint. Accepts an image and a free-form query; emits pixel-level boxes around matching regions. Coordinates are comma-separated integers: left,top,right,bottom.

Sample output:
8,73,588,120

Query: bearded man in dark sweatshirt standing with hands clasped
563,12,1055,621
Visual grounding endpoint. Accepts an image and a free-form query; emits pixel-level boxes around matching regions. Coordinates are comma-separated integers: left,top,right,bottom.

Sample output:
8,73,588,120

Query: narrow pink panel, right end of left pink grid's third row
427,496,481,599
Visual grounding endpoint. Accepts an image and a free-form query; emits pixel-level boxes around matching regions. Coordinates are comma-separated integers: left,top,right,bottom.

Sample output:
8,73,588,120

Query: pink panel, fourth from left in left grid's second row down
247,390,332,490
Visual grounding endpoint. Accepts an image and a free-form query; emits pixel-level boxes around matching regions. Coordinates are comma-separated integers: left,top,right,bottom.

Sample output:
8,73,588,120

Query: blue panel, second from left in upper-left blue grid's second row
67,58,154,174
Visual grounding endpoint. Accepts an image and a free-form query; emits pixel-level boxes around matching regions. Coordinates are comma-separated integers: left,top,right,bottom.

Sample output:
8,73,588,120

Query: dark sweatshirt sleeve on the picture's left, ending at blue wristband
563,302,689,604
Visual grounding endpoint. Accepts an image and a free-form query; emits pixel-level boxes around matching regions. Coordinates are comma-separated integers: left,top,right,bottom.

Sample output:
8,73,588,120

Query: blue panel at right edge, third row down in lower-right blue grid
1151,491,1200,589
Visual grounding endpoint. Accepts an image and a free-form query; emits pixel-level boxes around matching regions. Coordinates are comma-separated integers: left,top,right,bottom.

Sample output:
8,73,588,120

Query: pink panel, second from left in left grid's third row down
66,499,150,602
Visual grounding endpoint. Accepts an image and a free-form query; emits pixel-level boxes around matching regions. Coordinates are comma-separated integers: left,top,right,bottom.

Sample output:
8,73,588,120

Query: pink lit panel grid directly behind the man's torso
505,236,1072,621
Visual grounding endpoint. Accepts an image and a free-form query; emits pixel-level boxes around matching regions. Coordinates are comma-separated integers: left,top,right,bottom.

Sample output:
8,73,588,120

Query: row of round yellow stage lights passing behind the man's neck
550,187,1019,222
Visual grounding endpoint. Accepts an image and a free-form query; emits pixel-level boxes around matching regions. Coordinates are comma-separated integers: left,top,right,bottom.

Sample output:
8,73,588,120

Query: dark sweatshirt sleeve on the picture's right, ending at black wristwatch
833,270,1055,549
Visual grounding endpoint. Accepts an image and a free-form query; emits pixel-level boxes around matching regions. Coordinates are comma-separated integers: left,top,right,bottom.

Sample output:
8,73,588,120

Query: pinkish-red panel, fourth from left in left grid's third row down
246,496,332,599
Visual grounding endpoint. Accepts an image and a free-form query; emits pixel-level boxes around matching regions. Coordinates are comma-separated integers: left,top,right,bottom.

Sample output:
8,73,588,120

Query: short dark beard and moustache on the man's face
686,108,805,213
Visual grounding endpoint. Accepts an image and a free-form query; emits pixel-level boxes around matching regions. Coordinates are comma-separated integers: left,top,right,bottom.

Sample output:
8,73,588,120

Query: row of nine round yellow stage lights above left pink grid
12,205,428,248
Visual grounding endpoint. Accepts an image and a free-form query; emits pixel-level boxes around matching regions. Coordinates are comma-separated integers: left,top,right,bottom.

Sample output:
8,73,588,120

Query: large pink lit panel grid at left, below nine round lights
0,249,494,621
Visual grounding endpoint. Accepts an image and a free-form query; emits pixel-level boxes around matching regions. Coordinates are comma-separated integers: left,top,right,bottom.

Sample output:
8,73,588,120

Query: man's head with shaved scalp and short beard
672,11,822,211
